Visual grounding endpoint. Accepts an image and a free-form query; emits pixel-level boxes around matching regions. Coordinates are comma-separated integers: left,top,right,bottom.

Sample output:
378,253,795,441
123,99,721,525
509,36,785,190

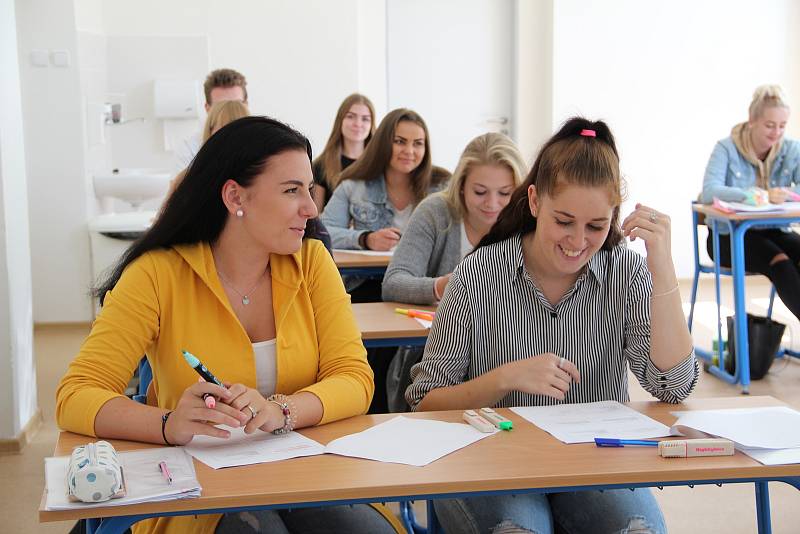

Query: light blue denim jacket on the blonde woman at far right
701,137,800,204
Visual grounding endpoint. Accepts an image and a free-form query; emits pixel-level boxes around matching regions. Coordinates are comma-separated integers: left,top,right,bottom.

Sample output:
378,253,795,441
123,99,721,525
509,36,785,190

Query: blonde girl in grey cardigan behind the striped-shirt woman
383,133,527,412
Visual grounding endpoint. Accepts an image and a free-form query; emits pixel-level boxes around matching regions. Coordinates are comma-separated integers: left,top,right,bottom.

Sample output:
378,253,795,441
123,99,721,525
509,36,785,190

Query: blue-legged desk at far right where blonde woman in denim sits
692,204,800,394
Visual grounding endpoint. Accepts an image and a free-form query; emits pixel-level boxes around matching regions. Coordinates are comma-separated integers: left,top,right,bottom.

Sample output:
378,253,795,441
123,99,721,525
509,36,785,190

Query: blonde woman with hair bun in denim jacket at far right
702,85,800,319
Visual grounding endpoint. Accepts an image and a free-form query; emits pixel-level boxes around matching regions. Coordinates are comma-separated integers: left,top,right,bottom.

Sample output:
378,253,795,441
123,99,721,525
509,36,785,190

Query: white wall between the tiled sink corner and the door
103,0,366,160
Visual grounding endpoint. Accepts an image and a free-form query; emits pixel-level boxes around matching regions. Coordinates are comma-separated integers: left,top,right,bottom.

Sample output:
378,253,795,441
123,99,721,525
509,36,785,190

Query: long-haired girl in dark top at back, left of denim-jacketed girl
311,93,375,213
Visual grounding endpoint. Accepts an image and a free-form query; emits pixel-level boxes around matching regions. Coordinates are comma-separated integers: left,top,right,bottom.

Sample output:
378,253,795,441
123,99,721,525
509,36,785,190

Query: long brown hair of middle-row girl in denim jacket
328,108,449,203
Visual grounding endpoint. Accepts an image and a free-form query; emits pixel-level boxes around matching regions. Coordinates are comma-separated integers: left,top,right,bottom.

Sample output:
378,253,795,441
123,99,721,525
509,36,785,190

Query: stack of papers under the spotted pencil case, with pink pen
44,447,202,510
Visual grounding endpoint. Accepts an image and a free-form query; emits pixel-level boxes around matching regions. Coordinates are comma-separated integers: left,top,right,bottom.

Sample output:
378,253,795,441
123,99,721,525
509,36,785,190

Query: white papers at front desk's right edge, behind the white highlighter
672,406,800,465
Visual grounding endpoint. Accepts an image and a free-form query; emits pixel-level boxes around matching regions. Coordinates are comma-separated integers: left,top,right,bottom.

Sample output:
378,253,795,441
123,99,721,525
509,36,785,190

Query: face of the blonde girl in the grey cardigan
462,164,514,233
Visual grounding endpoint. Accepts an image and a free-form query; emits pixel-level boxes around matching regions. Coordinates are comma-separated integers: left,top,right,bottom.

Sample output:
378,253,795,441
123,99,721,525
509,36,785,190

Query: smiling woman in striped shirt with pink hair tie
406,118,699,533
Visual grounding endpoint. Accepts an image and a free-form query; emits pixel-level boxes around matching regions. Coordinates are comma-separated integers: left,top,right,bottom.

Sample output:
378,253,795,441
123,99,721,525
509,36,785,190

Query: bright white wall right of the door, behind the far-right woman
552,0,800,277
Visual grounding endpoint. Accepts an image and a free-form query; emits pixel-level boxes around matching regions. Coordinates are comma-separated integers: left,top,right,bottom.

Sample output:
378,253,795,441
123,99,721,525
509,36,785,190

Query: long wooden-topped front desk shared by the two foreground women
39,397,800,534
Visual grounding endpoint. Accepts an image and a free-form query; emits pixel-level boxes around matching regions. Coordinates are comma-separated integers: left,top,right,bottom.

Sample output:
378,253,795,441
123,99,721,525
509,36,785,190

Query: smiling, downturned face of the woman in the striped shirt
528,185,614,277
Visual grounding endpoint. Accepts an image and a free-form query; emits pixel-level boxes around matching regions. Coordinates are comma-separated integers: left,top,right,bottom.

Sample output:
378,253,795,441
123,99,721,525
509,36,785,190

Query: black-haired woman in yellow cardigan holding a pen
56,117,396,534
